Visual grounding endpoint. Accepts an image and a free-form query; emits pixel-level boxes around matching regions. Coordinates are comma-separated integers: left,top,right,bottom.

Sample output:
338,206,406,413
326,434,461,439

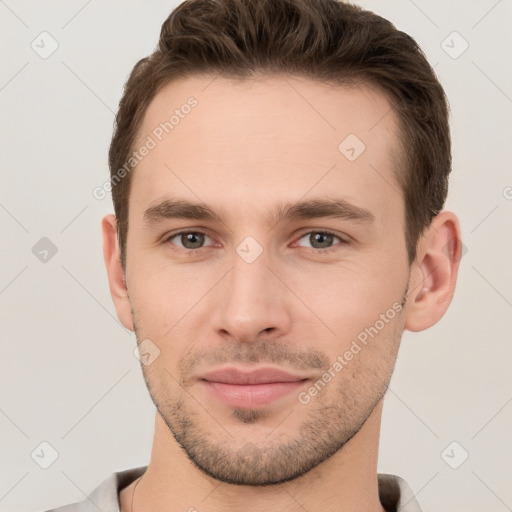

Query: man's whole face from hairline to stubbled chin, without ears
126,76,409,485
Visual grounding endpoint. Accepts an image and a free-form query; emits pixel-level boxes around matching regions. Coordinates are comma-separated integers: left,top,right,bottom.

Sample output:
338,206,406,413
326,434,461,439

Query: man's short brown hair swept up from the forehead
109,0,451,268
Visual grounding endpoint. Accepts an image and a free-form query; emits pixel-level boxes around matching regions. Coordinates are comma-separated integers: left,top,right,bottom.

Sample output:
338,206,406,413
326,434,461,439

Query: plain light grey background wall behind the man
0,0,512,512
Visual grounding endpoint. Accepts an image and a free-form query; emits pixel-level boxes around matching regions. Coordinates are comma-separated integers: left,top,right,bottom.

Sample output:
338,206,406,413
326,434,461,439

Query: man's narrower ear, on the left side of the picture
101,214,133,331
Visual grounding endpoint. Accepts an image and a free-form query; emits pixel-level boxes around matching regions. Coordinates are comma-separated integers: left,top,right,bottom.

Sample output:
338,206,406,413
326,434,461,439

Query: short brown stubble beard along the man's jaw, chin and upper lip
133,288,405,486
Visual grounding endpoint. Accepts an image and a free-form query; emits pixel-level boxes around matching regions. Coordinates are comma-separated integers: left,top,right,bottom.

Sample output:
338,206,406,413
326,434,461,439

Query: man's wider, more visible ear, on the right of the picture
405,211,462,332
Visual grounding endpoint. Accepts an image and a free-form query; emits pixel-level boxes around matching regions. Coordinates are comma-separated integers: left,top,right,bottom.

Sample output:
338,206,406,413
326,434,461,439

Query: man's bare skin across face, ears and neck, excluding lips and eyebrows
102,76,460,512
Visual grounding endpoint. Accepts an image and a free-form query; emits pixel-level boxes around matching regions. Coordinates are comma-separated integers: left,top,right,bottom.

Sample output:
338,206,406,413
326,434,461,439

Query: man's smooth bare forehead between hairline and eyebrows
130,75,401,228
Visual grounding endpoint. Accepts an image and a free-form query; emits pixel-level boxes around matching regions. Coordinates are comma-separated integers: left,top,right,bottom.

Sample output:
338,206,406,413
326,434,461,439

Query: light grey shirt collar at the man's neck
42,466,421,512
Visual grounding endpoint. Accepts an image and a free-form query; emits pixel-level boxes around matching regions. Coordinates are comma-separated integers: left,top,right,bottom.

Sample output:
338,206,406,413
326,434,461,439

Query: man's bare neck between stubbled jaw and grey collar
120,401,385,512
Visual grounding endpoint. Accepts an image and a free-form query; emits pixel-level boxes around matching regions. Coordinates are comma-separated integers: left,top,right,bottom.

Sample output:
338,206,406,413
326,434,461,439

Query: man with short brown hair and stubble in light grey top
46,0,461,512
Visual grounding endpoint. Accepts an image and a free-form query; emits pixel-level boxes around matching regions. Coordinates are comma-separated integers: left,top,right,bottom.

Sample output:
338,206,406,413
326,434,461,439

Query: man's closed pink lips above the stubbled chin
199,367,310,409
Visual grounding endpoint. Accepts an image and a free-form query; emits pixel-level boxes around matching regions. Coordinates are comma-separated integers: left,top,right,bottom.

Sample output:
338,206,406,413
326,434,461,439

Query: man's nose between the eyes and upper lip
213,249,292,343
